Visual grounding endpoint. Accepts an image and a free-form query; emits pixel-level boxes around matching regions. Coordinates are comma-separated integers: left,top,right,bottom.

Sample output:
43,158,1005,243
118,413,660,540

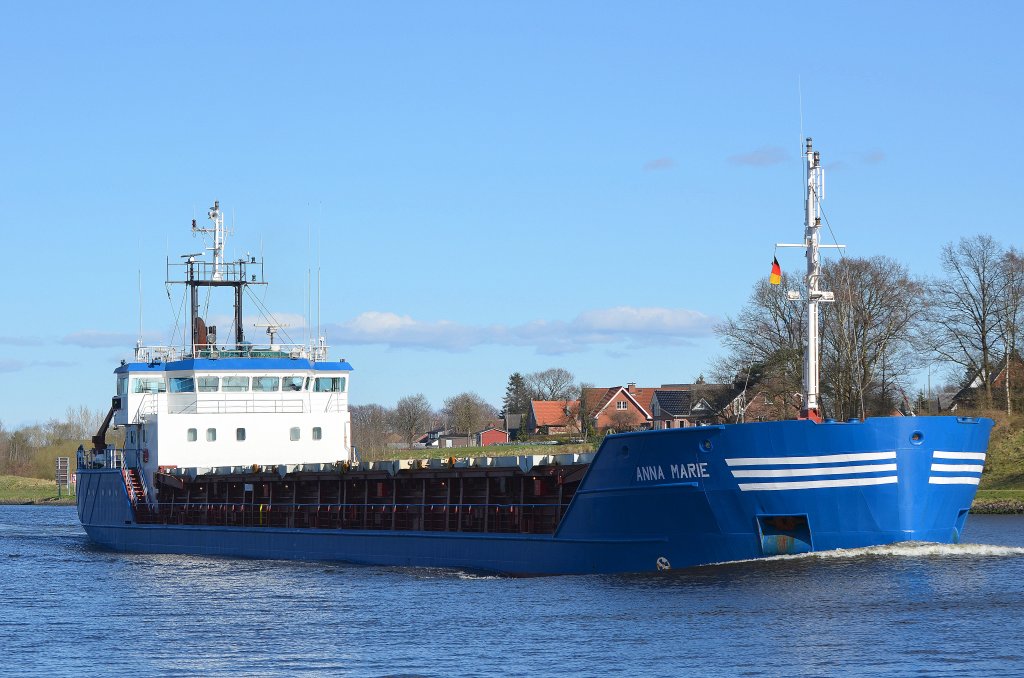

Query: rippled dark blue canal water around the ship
0,506,1024,677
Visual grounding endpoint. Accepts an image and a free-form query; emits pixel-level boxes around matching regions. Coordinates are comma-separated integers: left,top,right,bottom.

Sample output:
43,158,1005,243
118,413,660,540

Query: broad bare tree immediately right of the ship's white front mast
821,257,924,419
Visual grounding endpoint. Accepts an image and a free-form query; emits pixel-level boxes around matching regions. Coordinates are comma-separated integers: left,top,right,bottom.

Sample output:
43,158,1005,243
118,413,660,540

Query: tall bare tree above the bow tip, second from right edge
921,235,1004,407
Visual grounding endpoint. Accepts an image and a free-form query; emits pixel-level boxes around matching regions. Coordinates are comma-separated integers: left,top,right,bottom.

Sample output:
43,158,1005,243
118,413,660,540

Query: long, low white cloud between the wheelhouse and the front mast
326,306,717,354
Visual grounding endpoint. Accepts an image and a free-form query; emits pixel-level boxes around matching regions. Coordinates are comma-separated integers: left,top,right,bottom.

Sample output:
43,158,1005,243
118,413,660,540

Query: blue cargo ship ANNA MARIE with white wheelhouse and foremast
77,139,992,575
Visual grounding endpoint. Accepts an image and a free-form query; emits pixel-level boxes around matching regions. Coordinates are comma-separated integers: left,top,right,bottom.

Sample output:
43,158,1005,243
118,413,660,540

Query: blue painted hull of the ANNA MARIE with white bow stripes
78,417,992,575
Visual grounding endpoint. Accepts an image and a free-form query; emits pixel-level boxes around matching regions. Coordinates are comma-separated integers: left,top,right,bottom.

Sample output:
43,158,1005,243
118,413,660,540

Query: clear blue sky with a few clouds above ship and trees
0,1,1024,427
